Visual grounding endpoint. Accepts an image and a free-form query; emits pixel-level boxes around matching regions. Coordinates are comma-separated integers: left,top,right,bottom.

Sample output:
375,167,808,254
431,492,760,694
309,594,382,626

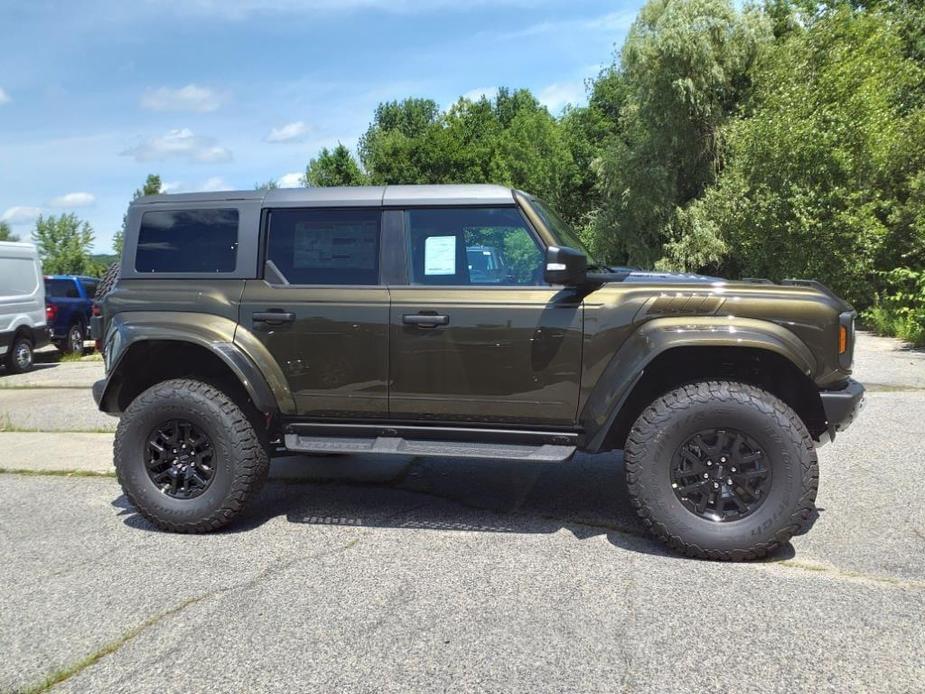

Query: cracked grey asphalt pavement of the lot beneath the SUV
0,335,925,692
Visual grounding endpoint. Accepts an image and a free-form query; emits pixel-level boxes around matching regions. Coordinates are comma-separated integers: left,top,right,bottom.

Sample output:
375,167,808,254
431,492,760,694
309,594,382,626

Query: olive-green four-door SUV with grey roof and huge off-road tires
93,185,864,559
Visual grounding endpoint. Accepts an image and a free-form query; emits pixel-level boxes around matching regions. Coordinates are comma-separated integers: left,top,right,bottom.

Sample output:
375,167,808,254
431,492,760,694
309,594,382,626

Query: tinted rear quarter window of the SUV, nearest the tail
135,209,238,274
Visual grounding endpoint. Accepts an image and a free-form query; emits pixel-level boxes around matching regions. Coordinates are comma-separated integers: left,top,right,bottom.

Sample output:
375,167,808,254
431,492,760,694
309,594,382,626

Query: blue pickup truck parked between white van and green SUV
45,275,99,353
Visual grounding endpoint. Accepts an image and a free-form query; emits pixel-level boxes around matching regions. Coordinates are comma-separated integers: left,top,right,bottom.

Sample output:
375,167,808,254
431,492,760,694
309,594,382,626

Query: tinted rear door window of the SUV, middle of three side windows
267,208,381,285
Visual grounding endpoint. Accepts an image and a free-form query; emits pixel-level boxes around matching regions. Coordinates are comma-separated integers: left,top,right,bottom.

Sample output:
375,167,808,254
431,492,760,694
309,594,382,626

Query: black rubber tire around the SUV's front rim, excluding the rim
624,381,819,561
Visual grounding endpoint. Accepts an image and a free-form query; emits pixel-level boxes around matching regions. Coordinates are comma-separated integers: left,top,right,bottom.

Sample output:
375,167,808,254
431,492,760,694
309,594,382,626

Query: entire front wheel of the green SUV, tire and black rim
625,381,819,561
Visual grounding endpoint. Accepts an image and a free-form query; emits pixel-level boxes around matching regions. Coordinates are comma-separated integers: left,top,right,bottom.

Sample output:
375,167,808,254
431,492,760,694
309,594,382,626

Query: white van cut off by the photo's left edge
0,241,48,373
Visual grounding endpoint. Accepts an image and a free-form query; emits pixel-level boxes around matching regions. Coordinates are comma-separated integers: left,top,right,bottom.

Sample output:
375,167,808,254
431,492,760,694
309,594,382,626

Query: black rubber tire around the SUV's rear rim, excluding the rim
113,379,269,533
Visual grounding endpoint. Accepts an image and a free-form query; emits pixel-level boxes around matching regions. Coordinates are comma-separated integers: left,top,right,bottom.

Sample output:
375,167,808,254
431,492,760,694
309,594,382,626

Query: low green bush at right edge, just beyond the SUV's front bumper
862,268,925,346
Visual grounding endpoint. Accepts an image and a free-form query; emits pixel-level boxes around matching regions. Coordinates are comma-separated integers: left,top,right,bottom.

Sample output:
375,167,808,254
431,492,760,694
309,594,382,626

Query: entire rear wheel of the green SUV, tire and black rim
114,379,269,533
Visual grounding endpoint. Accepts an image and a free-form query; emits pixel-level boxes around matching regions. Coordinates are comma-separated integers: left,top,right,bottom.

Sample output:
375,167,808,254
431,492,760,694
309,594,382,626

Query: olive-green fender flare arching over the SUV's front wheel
579,316,817,451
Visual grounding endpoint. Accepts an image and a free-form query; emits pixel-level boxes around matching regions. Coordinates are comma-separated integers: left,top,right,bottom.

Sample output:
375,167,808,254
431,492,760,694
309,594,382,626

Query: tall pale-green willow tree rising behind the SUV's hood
594,0,772,265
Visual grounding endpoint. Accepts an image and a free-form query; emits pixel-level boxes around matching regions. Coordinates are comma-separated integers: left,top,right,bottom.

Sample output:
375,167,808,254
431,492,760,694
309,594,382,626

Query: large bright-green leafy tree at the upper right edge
692,5,925,308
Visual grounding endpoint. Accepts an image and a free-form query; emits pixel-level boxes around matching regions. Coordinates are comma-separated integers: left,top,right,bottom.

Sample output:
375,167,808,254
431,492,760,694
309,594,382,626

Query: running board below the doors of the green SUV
285,434,575,463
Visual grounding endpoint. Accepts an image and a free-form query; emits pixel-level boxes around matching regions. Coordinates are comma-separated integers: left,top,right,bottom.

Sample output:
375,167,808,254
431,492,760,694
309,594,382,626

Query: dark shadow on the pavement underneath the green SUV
113,453,795,561
